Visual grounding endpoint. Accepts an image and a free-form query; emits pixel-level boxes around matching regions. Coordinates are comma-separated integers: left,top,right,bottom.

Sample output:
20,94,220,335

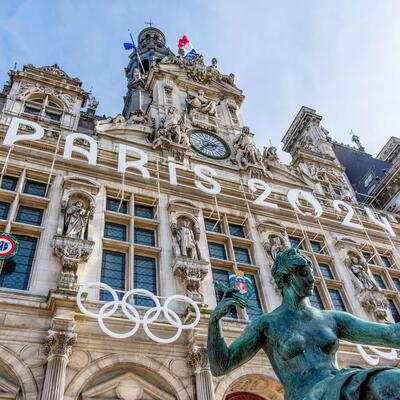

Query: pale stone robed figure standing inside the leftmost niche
64,200,91,239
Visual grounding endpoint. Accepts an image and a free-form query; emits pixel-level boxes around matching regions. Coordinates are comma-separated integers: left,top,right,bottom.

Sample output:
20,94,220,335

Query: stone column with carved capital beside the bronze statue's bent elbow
188,346,215,400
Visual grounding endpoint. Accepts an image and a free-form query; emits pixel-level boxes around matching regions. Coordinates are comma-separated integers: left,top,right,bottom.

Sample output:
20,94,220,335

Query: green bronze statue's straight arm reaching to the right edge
333,311,400,349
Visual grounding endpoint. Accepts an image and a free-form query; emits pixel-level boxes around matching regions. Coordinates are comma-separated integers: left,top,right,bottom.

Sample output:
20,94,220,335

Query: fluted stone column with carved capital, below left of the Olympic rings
41,330,76,400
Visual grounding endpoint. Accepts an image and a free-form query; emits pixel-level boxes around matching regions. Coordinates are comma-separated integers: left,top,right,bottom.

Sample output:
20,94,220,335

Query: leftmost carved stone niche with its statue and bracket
53,176,99,290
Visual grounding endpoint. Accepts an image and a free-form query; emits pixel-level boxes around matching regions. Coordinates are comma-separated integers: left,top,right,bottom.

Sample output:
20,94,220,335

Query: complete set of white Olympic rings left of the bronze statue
76,282,200,343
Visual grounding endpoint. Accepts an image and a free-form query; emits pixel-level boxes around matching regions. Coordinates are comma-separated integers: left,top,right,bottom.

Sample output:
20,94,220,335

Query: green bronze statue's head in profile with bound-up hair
272,248,314,297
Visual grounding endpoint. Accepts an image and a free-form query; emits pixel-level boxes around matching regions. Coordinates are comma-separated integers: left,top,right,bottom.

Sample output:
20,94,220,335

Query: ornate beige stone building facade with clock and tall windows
0,27,400,400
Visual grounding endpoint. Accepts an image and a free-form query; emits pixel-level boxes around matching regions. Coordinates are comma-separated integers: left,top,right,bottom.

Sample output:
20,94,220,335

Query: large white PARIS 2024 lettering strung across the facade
3,117,396,237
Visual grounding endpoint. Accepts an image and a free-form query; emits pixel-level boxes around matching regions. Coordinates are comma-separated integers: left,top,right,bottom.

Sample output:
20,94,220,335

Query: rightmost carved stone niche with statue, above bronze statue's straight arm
335,238,389,321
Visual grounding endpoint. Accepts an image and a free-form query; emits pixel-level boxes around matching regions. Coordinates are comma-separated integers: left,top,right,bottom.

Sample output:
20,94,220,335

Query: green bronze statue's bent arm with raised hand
207,290,265,376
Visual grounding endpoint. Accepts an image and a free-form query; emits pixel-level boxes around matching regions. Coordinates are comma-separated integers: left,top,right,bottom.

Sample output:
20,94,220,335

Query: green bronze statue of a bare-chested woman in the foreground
208,248,400,400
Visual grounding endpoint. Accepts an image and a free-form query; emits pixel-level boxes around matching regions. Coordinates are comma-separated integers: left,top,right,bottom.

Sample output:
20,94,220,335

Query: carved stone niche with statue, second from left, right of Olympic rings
168,201,208,304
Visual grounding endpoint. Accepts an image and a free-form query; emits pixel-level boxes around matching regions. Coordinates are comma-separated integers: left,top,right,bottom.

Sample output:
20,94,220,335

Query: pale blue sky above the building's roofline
0,0,400,161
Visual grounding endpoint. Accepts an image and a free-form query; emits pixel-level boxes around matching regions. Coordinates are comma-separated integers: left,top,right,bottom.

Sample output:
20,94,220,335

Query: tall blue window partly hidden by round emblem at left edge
0,235,37,290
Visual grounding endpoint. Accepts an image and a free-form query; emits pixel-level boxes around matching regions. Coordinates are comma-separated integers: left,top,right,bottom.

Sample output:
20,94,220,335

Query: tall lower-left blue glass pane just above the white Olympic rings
100,250,125,301
